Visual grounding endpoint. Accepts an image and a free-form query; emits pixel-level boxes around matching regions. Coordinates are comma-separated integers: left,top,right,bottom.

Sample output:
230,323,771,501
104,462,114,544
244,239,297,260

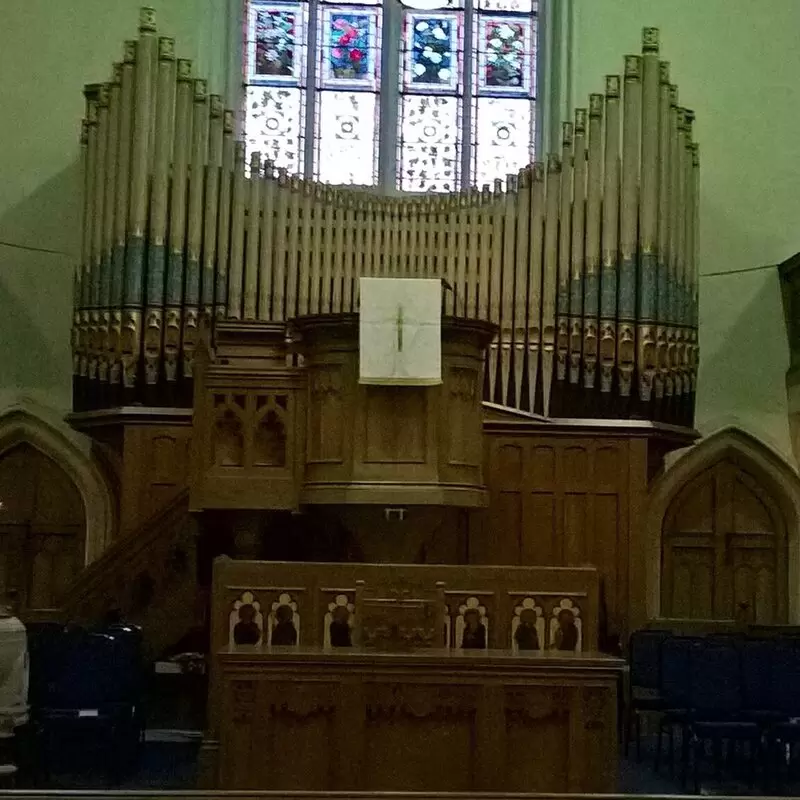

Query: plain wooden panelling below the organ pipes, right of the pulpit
478,432,646,634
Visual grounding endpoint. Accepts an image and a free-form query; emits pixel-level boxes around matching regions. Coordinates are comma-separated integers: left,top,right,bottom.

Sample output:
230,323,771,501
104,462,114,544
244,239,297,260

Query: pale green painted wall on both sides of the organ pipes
0,0,800,462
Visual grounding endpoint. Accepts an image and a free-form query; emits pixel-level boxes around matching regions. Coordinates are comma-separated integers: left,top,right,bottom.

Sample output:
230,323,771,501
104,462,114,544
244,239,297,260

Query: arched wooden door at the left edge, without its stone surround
0,444,86,610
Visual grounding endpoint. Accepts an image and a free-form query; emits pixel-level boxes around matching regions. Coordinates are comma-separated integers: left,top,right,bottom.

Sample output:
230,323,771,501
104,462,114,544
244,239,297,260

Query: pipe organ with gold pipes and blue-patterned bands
73,8,699,424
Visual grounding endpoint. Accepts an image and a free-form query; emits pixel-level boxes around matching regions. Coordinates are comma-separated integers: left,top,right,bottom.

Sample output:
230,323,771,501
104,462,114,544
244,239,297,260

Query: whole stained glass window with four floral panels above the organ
243,0,537,192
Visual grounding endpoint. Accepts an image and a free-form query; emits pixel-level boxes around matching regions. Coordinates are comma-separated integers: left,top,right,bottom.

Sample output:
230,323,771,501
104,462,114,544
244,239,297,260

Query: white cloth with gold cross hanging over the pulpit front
359,278,442,386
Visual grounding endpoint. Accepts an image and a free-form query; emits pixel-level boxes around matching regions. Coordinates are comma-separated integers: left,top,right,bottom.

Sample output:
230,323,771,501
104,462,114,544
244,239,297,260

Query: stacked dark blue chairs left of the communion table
29,625,144,784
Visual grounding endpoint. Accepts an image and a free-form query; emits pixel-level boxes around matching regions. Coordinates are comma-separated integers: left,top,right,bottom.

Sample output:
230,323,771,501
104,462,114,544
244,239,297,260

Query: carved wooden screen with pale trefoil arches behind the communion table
211,559,598,652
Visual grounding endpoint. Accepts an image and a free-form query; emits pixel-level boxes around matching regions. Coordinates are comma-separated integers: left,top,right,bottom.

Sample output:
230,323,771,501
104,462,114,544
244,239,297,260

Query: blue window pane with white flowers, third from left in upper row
404,13,460,91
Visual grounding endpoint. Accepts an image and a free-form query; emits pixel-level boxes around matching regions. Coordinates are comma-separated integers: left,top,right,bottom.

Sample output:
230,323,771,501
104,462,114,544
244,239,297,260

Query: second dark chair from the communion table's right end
655,636,702,781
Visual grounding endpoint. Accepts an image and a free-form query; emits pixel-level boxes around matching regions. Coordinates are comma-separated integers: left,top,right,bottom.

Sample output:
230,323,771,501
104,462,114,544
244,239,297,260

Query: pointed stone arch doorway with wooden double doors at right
648,429,800,624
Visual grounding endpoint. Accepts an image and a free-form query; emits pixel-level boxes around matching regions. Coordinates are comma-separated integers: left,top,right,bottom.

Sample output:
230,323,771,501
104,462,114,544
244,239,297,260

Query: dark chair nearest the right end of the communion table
625,630,672,761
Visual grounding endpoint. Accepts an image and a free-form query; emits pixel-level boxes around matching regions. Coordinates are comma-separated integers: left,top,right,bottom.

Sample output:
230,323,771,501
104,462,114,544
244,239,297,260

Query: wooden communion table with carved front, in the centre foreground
216,644,622,793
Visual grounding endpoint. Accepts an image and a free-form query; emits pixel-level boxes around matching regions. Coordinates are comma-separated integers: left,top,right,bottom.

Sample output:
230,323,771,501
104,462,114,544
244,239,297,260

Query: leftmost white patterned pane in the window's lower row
245,86,305,173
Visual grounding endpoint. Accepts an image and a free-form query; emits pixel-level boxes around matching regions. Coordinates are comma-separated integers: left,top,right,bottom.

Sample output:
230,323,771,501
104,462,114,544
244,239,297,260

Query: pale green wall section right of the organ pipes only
573,0,800,458
